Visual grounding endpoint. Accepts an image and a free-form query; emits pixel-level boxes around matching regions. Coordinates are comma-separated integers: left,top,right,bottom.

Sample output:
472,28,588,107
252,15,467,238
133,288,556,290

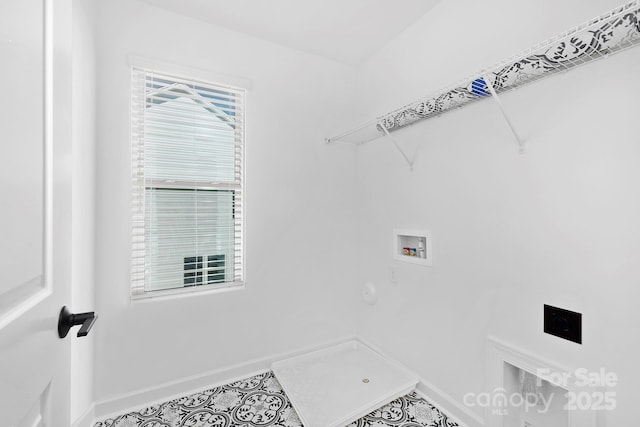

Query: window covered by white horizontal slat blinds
131,68,244,297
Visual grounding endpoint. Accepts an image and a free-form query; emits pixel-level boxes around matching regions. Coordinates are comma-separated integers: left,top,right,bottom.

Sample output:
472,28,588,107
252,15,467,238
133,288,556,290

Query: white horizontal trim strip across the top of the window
127,53,251,90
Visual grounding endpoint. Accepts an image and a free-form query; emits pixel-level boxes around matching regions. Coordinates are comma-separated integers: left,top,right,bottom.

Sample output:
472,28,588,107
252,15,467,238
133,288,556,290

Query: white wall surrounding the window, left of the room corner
95,0,355,410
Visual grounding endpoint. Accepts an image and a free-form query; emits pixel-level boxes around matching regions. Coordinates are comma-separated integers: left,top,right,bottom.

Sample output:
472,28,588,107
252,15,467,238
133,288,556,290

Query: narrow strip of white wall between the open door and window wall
69,0,100,421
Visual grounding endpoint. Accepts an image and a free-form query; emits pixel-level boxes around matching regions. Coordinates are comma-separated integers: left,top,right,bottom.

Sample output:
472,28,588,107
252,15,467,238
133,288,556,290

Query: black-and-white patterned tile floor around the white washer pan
94,372,458,427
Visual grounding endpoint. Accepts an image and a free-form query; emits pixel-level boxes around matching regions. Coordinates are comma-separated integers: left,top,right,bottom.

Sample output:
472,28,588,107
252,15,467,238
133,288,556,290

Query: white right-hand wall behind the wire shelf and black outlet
357,0,640,426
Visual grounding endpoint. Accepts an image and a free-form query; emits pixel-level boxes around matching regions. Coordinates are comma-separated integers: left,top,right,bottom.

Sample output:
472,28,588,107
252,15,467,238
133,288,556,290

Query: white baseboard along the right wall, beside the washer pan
357,338,484,427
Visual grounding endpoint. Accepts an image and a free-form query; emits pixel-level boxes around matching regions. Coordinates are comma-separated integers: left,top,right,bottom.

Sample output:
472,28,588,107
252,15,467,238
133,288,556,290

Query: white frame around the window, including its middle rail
128,55,250,301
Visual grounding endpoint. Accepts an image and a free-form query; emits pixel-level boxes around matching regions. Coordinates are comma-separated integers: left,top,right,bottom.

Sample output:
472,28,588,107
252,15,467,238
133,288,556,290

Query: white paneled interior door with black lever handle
0,0,71,427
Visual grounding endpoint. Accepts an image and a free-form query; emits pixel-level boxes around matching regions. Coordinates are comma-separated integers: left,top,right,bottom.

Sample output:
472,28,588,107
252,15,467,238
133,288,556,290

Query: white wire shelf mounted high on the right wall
326,0,640,145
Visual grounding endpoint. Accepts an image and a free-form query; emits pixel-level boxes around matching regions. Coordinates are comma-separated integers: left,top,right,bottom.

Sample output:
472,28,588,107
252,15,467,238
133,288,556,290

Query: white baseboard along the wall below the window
94,336,357,427
